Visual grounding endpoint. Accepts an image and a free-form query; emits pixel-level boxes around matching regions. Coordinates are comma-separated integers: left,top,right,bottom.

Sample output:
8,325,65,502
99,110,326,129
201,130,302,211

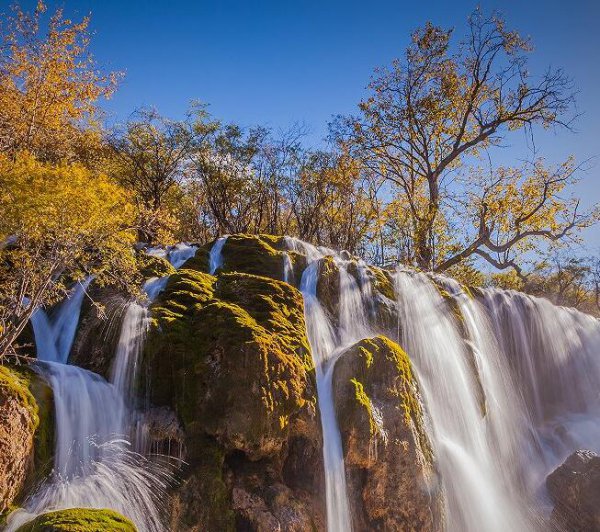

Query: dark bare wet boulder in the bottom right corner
546,450,600,532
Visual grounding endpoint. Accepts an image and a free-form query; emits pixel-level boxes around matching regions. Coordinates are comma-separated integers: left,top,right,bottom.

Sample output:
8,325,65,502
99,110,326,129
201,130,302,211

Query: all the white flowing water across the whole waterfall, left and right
8,236,600,532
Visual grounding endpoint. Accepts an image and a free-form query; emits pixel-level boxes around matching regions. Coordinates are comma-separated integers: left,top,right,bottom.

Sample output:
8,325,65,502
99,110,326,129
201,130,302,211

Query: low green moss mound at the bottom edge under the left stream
17,508,137,532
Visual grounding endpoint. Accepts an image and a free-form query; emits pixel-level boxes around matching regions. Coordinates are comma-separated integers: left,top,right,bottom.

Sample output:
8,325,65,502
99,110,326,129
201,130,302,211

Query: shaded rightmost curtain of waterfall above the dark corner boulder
483,290,600,495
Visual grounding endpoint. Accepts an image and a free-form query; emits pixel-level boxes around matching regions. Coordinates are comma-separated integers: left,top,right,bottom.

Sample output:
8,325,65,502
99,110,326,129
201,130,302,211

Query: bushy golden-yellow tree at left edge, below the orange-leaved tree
0,154,135,358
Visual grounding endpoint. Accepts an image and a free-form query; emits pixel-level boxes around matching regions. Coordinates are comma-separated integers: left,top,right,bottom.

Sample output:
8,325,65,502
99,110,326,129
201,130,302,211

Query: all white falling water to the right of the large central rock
283,238,600,532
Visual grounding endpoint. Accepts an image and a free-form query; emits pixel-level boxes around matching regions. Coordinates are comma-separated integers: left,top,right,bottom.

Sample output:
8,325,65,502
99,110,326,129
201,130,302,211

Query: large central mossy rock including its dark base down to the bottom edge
145,268,318,530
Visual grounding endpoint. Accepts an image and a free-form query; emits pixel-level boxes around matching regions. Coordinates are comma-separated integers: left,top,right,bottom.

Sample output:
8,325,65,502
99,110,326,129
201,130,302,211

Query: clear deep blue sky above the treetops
7,0,600,247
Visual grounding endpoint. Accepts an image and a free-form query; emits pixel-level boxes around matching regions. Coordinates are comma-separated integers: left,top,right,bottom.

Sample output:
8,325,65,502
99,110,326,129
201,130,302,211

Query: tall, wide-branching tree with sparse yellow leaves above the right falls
333,10,597,271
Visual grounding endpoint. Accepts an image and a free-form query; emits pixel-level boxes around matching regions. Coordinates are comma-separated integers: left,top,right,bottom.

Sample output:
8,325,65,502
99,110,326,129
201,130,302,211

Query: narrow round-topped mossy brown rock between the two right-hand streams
333,336,442,531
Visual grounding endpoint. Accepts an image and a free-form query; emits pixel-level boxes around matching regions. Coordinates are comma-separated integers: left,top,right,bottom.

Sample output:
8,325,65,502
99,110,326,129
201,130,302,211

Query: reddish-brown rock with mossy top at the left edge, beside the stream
0,365,54,513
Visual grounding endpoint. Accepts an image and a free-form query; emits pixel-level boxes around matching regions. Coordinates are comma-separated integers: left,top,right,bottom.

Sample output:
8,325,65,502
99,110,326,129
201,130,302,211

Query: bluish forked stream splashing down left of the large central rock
7,245,197,532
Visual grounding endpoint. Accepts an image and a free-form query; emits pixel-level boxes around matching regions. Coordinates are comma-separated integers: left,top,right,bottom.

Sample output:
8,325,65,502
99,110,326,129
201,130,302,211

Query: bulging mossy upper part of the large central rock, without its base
146,270,314,456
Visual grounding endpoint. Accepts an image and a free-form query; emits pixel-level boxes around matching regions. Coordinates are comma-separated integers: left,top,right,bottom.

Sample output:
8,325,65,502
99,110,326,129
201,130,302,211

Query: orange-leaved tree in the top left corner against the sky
0,2,120,162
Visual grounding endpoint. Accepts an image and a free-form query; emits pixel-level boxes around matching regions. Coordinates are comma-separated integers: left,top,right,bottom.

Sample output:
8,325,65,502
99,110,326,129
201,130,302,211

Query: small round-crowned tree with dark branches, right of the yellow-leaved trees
108,104,218,242
